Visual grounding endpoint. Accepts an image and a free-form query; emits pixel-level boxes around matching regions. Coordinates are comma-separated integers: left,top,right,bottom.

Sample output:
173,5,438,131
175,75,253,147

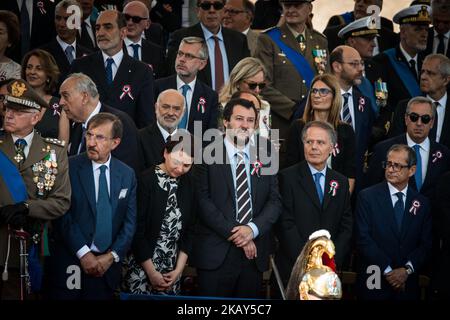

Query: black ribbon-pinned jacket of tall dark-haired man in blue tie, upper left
70,51,155,128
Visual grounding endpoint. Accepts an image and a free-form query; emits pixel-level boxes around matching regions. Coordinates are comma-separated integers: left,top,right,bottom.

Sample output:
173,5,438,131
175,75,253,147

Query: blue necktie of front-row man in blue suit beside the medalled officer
94,165,112,252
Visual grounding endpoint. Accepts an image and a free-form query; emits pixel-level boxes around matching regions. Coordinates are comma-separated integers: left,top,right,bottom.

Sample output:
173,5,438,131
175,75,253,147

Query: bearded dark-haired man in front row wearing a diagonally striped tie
191,99,281,298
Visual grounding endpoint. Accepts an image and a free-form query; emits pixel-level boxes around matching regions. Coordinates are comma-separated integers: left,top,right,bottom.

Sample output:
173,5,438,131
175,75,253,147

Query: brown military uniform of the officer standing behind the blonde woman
254,18,329,152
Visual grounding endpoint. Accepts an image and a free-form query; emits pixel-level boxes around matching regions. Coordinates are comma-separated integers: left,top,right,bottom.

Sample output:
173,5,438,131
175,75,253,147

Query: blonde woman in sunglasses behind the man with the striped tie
218,57,270,138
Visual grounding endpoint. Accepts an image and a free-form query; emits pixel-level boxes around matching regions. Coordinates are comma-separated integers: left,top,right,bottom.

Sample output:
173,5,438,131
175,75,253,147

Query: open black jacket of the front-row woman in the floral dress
131,166,195,263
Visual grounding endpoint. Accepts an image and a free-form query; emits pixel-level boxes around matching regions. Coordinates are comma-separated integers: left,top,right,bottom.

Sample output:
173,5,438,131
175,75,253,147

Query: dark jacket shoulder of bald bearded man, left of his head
139,122,165,169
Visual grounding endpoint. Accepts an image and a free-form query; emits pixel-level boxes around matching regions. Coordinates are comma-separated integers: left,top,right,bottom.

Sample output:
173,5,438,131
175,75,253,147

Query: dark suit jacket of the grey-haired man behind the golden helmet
275,161,353,284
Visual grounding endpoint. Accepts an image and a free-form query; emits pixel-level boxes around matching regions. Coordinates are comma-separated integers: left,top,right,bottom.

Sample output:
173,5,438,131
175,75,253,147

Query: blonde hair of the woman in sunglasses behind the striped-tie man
219,57,267,103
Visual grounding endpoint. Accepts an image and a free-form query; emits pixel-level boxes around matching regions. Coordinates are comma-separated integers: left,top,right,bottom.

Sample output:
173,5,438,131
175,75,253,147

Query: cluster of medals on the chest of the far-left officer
32,150,58,197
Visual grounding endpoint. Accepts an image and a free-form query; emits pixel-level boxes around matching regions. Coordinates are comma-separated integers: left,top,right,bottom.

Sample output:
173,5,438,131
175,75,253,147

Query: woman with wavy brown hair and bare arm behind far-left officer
22,49,70,142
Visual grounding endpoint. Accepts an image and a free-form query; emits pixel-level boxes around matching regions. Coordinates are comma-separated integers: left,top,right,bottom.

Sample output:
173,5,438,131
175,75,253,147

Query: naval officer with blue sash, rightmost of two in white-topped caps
369,5,431,112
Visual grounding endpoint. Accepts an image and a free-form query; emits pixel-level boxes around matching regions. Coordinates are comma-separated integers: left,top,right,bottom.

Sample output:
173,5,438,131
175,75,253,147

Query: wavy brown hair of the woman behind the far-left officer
21,49,60,94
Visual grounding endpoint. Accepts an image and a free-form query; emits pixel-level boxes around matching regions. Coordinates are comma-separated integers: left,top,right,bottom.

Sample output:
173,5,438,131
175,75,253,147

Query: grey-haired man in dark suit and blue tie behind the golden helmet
275,121,352,285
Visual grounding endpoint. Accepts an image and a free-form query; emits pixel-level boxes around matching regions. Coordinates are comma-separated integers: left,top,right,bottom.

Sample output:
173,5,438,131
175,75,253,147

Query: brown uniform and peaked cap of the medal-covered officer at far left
0,80,71,300
